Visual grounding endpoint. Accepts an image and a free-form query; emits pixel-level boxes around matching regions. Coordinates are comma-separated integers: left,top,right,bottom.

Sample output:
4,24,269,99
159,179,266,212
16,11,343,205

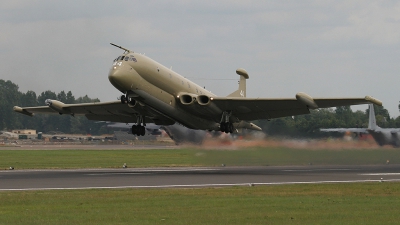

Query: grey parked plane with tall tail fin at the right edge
320,104,400,147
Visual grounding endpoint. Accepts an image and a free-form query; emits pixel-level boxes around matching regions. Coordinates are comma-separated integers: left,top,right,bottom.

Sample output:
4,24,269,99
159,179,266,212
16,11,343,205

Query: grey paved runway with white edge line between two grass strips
0,165,400,191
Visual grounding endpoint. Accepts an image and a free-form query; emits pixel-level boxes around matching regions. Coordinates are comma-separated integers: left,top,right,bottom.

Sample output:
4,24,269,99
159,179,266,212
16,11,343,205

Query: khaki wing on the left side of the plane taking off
14,100,175,125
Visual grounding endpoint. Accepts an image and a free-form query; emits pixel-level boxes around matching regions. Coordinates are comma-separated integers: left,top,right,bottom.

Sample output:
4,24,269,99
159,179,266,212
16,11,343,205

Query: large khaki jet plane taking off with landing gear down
14,43,382,135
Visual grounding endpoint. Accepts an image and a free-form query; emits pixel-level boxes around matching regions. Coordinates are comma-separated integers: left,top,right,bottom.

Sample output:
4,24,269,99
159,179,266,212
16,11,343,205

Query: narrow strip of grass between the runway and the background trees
0,147,400,169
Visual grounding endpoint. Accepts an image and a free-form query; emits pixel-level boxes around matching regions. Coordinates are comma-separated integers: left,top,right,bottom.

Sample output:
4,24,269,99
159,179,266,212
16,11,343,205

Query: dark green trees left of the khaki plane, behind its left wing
0,79,108,135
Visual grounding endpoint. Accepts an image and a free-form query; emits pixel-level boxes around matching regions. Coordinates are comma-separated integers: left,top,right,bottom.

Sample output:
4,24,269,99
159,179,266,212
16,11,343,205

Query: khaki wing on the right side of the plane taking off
211,93,382,120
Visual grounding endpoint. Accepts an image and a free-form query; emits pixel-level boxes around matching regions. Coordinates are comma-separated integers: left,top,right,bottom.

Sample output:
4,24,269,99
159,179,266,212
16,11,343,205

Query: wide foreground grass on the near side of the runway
0,182,400,224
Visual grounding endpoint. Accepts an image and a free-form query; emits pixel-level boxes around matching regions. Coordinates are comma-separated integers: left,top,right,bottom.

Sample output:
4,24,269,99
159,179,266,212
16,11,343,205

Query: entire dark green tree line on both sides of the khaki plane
0,79,400,137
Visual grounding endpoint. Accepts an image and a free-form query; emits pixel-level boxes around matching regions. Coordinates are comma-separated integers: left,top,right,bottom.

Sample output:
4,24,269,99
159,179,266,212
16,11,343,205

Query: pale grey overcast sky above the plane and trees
0,0,400,117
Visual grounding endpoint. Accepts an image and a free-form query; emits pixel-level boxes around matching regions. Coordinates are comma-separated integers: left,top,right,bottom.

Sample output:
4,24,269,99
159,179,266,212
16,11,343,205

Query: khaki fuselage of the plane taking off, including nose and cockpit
108,52,222,130
